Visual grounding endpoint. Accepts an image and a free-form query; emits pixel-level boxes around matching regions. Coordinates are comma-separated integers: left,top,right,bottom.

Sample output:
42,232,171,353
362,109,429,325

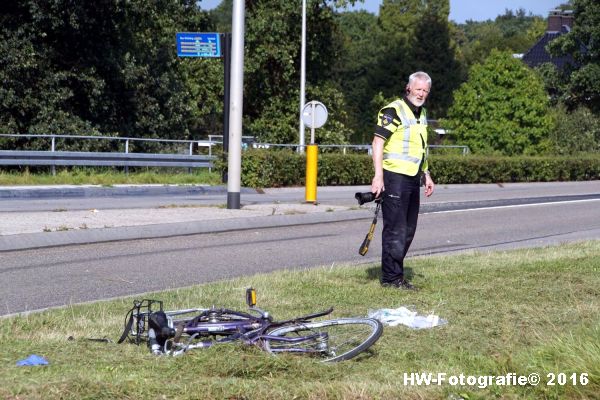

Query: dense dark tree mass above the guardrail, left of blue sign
0,0,216,147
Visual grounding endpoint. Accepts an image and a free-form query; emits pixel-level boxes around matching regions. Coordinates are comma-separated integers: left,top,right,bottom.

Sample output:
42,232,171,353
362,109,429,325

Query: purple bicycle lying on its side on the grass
119,293,383,361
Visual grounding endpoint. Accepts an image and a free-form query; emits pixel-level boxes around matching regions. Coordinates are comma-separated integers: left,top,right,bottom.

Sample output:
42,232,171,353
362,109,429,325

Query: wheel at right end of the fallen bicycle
263,318,383,362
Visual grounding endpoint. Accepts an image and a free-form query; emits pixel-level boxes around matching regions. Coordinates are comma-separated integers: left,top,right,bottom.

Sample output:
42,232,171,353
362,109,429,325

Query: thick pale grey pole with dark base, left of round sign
227,0,245,209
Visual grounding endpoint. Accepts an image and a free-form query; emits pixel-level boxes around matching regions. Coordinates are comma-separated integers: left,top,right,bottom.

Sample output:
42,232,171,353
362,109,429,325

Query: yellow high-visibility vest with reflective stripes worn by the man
380,99,428,176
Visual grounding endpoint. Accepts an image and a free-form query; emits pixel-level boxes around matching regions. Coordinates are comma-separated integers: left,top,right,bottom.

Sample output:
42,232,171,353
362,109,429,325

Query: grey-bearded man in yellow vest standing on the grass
371,72,434,290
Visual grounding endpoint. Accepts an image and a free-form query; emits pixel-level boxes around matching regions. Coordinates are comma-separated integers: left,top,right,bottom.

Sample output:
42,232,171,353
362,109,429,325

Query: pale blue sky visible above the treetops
200,0,566,24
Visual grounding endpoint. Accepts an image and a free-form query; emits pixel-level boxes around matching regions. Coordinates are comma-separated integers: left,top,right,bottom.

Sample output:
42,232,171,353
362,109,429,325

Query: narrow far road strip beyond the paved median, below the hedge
0,181,600,212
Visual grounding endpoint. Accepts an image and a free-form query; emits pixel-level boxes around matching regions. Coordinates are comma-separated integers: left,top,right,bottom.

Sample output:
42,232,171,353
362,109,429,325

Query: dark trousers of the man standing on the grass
381,170,421,283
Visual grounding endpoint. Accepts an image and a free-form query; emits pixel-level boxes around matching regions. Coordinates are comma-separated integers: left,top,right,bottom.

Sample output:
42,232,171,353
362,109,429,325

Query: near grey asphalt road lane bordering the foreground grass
0,196,600,315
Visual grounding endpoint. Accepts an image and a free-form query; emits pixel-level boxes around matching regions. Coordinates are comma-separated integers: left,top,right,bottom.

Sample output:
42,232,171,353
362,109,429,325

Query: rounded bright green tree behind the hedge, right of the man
443,50,551,155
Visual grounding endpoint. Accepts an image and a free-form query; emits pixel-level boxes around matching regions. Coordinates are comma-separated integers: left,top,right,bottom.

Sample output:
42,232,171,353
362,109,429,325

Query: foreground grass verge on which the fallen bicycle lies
0,241,600,399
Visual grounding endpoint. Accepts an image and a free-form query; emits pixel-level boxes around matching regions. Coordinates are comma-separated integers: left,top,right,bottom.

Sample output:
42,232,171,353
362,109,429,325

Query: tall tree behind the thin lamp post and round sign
238,0,350,144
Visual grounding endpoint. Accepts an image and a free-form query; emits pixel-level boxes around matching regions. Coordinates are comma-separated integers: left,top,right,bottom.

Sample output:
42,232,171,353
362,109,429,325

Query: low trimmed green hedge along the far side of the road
226,150,600,188
